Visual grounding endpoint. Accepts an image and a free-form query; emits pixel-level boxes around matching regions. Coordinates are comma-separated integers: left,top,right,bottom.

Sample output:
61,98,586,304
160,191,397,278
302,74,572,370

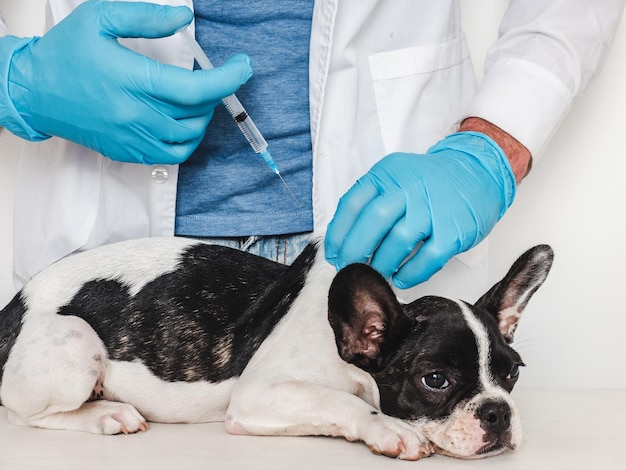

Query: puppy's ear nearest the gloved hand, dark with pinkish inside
328,264,413,373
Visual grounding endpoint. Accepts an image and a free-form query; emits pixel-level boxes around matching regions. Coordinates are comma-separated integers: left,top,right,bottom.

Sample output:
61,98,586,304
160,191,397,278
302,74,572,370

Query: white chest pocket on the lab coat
369,36,476,153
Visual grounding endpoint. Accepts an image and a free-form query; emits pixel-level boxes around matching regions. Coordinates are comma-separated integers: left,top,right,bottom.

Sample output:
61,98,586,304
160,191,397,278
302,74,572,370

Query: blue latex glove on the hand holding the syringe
0,1,252,164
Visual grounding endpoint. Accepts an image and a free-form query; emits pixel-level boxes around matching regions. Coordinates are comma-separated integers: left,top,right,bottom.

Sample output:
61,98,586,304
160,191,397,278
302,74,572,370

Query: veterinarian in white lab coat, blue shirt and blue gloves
0,0,624,300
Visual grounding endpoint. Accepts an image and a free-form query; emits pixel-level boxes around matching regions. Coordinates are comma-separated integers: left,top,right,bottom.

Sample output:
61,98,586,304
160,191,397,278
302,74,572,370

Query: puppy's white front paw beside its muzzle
361,412,434,460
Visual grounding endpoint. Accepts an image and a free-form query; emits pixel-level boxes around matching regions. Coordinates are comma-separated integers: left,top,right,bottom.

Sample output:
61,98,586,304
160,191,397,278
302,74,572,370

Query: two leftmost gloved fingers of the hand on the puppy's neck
326,173,406,269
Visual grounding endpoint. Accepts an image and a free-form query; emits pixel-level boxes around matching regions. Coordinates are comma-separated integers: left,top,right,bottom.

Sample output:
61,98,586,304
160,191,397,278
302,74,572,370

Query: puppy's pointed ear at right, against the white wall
476,245,554,343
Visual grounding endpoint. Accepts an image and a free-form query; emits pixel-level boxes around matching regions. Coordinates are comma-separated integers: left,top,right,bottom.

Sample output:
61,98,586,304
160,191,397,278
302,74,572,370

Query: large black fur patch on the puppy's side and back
59,243,317,382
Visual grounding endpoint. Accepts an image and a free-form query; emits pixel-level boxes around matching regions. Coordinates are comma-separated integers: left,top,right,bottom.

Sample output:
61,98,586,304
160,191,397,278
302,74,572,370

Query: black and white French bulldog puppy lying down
0,238,552,459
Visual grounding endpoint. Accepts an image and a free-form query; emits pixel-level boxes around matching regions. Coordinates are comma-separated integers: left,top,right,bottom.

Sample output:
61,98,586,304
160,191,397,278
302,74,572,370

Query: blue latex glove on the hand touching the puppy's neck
325,132,516,289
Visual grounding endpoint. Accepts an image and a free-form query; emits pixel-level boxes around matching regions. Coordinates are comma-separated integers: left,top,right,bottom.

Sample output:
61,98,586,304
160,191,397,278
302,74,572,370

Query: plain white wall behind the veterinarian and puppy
0,0,626,388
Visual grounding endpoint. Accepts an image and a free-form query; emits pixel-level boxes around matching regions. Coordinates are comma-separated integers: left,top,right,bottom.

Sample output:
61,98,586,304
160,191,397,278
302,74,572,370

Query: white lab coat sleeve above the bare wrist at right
468,0,625,159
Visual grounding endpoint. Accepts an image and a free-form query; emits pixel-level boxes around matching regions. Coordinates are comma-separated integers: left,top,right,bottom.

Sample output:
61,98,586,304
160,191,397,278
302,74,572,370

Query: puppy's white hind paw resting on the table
83,400,150,434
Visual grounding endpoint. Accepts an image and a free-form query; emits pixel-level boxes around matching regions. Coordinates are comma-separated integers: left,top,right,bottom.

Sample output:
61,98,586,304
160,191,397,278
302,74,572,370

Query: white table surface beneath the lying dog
0,388,626,470
